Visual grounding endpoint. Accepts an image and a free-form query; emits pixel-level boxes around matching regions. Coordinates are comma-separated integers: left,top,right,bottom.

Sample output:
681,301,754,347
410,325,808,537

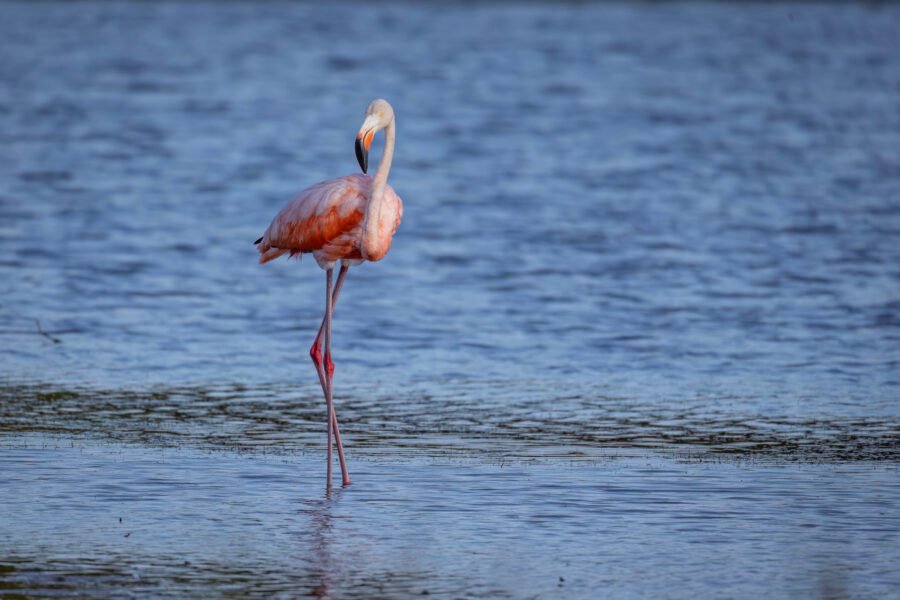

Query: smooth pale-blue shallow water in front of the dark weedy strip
0,435,900,598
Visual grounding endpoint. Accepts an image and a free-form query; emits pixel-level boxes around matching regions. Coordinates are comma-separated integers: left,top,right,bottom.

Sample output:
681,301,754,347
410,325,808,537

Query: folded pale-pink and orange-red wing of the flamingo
258,175,372,263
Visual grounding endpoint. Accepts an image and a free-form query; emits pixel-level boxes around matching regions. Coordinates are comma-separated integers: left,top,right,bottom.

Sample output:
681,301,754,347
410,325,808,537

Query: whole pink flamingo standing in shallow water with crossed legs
256,99,403,487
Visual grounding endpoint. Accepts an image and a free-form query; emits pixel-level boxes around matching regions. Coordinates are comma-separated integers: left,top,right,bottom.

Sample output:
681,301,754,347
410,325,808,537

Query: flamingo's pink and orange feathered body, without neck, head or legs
259,174,403,269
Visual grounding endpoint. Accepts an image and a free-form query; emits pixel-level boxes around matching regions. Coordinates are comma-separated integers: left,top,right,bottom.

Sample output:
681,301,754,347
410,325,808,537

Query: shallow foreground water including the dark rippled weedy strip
0,383,900,598
